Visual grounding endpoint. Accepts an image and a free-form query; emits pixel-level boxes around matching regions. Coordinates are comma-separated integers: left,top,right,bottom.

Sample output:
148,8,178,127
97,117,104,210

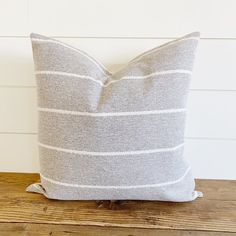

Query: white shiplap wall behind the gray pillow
0,0,236,179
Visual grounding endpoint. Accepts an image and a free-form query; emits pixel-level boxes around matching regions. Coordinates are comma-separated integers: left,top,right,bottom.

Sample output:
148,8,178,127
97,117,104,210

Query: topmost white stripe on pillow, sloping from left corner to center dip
31,38,111,76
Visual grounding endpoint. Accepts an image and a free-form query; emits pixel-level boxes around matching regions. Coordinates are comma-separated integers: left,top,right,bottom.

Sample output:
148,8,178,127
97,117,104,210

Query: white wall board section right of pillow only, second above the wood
186,91,236,139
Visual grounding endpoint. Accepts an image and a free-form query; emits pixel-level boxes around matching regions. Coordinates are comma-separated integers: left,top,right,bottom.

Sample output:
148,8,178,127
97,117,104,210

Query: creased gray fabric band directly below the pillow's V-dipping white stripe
37,74,190,112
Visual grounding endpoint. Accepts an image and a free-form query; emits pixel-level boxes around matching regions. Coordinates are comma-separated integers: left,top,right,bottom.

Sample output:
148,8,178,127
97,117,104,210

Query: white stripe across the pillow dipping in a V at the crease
35,69,192,87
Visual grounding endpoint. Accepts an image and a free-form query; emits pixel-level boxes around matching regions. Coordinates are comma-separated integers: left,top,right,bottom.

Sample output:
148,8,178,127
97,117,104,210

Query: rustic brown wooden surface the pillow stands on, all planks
0,173,236,236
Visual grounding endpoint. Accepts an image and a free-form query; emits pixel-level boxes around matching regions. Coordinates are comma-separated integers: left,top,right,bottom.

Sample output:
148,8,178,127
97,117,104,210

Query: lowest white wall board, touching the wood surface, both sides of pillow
0,134,236,179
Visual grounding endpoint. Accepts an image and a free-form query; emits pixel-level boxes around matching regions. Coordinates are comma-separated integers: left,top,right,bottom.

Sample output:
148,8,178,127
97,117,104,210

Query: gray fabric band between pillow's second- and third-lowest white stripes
39,112,185,152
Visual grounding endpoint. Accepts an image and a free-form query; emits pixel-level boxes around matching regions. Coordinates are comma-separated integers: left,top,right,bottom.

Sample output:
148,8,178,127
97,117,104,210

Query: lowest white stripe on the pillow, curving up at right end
40,167,191,189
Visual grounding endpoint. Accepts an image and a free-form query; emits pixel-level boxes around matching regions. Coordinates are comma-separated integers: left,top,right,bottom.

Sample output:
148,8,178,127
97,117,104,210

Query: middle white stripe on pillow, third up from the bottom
38,107,186,117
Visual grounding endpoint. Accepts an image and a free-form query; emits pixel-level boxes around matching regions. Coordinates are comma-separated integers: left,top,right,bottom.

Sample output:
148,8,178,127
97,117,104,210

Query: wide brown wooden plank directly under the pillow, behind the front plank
0,173,236,233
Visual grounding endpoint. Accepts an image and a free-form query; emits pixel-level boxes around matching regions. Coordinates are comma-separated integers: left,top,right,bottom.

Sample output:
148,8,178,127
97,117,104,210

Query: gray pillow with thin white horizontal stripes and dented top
27,32,201,202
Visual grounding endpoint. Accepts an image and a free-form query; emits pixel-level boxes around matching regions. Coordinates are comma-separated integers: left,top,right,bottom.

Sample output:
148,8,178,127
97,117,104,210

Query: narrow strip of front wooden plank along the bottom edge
0,223,236,236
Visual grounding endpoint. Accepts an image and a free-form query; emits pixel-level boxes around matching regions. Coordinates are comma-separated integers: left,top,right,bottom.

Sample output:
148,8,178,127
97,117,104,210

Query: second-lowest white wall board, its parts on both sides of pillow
0,88,236,139
